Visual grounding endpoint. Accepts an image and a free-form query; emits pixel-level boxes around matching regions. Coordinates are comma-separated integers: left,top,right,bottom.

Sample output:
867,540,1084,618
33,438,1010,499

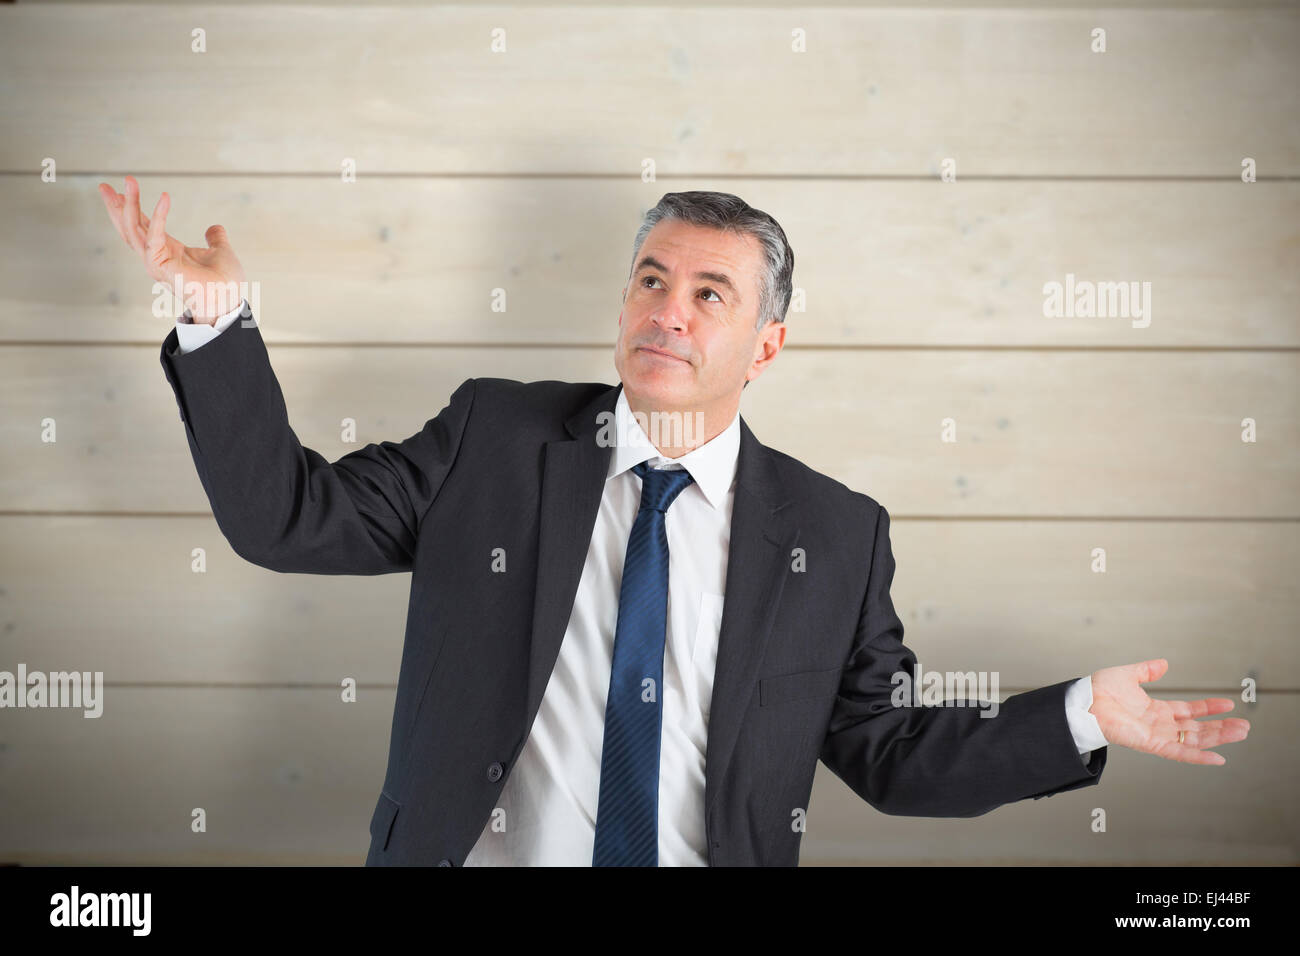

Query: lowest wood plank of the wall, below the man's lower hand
0,688,1284,865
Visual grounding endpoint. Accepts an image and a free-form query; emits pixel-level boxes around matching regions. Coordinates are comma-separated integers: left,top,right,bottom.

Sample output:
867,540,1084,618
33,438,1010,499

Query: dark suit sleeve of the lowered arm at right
822,506,1106,817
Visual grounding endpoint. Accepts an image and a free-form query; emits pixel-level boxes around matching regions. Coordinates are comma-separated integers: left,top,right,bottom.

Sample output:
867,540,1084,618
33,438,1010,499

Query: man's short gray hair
628,190,794,329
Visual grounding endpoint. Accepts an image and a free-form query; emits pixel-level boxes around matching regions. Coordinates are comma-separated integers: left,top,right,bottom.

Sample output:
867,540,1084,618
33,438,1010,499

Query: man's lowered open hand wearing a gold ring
1089,658,1251,763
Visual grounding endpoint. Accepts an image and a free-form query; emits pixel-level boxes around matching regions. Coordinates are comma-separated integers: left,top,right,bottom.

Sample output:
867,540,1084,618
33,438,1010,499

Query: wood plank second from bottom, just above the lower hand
0,516,1300,693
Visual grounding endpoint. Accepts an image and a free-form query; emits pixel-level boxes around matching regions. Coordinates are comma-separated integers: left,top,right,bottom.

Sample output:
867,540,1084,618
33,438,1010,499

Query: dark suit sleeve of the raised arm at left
161,308,475,575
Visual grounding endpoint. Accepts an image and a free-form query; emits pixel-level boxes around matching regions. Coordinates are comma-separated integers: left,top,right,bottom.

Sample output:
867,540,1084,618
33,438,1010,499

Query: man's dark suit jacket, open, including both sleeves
161,321,1106,866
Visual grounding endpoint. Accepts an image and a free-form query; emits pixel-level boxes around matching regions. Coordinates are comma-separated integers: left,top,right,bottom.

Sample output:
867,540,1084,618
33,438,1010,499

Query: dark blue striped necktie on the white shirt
592,462,693,866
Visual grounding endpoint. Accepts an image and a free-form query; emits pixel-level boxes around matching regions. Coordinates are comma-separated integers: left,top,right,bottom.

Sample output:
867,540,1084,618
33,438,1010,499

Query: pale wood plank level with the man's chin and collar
0,346,1300,518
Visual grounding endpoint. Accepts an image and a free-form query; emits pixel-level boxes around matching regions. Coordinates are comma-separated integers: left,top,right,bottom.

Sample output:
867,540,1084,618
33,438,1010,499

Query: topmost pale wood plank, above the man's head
0,5,1300,178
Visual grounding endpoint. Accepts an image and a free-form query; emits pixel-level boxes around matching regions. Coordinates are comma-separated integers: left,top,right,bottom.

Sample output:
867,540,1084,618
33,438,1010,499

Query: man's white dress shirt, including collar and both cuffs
177,303,1106,866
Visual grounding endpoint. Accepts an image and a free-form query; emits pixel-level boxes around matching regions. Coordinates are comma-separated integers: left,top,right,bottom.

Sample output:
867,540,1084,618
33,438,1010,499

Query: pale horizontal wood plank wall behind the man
0,1,1300,864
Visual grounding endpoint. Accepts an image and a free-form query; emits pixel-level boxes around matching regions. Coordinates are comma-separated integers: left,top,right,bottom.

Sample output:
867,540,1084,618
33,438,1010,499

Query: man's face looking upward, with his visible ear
614,220,785,427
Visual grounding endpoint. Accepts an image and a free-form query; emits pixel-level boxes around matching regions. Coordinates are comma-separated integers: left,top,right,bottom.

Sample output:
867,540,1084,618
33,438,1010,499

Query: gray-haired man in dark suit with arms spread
103,177,1247,866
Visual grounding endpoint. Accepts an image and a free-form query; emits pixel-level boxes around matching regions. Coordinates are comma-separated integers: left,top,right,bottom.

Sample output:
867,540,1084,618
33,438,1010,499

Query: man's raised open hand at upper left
99,176,246,325
